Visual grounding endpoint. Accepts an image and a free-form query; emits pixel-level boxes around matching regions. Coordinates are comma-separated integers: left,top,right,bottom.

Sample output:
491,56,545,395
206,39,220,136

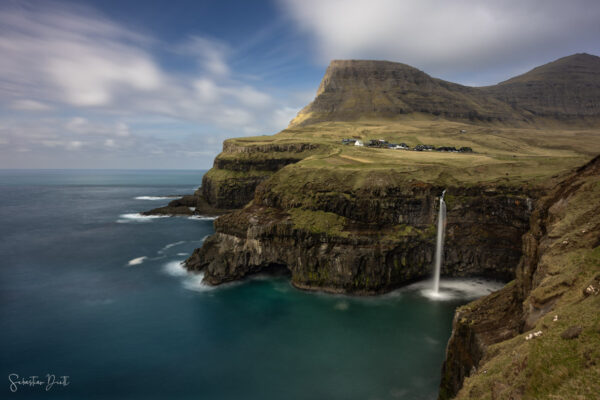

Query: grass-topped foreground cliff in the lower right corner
440,157,600,399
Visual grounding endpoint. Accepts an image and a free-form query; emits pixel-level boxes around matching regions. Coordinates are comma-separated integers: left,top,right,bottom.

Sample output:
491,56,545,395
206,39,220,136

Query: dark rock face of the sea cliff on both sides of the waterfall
187,181,532,294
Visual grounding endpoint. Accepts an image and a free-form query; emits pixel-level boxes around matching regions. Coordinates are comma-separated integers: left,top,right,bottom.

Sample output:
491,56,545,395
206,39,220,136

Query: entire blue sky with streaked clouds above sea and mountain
0,0,600,169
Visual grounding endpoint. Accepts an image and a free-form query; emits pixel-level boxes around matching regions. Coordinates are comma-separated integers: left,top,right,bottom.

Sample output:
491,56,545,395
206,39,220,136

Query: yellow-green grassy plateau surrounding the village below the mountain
213,116,600,192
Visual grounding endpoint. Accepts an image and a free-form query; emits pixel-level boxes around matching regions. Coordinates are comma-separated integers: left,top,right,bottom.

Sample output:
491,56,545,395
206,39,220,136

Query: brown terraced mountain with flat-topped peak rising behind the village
290,54,600,127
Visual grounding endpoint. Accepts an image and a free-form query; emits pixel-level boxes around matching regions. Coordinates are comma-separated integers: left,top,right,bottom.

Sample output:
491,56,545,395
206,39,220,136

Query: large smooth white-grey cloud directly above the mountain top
281,0,600,82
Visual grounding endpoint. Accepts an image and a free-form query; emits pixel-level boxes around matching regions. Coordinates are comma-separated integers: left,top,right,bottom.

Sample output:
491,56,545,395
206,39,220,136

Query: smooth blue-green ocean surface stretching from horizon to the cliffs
0,170,497,400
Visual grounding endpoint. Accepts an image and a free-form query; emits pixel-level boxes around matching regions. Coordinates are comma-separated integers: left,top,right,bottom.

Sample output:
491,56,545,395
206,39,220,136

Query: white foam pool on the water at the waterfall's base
410,279,504,301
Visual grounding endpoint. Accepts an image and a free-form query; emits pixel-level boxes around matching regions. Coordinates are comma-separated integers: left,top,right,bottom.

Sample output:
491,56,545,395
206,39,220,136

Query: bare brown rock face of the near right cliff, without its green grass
439,156,600,400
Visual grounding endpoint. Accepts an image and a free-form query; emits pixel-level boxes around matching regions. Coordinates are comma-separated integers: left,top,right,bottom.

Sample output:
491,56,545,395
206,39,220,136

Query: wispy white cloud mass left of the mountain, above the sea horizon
0,2,303,167
